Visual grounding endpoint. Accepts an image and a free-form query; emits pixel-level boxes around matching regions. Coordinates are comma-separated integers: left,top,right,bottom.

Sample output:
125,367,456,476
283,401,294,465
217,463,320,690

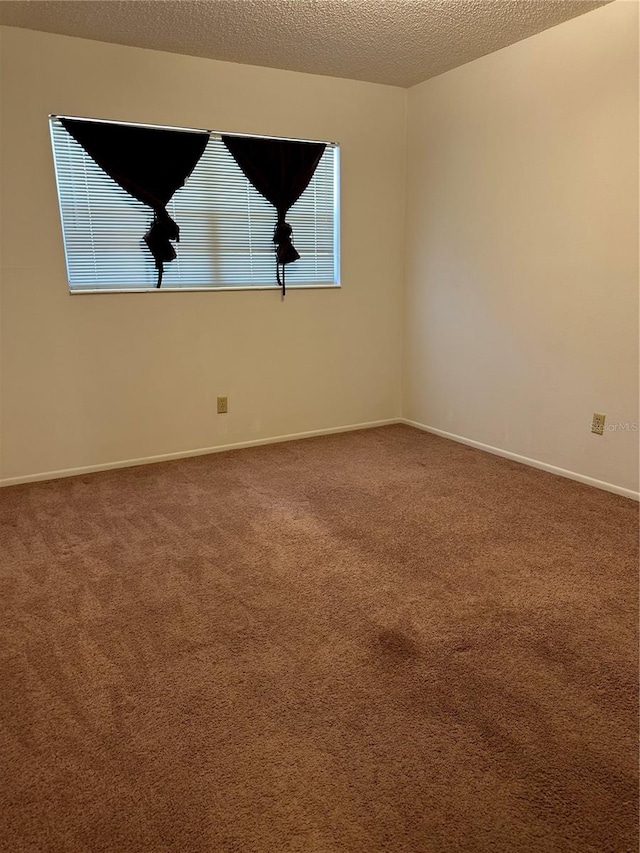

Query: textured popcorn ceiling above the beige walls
0,0,610,86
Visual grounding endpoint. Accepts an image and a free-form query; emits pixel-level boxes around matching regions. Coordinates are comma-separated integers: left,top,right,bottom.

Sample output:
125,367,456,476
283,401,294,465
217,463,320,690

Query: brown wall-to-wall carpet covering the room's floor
0,426,638,853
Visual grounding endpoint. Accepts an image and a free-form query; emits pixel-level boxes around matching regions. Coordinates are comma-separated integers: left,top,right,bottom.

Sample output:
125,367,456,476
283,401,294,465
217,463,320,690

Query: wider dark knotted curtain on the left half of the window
60,118,209,287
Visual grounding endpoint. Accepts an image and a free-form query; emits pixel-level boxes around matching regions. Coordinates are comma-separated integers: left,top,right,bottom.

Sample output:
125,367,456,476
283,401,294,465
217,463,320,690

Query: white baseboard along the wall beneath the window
0,418,401,488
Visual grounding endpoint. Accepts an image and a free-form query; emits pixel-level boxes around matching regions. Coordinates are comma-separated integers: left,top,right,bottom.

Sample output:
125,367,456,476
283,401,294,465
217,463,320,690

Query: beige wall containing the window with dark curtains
0,28,406,480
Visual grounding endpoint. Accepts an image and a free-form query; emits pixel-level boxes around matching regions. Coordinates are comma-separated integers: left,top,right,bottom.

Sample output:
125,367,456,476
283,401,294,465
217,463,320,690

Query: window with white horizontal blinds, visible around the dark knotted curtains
50,117,339,292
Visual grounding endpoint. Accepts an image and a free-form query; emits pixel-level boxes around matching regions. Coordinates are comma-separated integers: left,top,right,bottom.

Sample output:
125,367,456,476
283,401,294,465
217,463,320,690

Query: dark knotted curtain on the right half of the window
222,136,326,294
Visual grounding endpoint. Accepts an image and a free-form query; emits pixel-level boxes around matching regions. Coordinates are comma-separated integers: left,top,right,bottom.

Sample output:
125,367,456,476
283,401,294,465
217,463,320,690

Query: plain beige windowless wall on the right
403,0,638,490
